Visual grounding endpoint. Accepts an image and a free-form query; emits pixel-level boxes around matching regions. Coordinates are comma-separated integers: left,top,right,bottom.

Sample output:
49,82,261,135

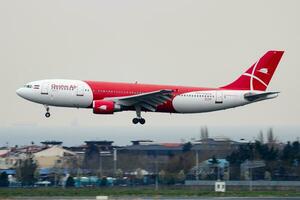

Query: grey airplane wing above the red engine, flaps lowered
105,90,173,111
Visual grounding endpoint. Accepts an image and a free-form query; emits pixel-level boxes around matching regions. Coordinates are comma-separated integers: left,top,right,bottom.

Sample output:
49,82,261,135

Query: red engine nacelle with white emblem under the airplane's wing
93,100,121,114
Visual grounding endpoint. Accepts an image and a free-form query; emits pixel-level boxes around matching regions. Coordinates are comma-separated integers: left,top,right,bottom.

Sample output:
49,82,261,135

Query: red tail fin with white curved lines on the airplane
221,51,284,91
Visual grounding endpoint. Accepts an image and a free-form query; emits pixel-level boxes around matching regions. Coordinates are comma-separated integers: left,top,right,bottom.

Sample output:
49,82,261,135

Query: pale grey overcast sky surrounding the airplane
0,0,300,144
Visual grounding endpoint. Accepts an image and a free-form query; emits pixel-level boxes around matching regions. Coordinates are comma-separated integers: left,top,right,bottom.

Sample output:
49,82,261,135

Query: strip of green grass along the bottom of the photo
0,187,300,197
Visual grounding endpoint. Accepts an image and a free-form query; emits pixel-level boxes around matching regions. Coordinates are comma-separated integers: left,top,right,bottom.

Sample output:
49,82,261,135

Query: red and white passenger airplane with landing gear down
16,50,284,124
